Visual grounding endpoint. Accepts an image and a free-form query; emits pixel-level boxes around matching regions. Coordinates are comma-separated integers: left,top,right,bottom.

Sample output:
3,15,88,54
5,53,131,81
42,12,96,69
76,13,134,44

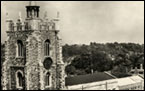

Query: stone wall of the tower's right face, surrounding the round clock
35,30,56,90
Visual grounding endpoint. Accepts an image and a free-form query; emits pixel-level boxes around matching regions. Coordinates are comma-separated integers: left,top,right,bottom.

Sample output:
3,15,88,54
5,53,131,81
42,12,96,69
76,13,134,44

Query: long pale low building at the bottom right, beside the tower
66,73,144,90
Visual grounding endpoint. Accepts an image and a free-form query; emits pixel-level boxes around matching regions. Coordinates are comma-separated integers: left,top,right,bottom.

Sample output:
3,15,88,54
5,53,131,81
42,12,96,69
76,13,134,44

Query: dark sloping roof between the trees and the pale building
65,72,115,86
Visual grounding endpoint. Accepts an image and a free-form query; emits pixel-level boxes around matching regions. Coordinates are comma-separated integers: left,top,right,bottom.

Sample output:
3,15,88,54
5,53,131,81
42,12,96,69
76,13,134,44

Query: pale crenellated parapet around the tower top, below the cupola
6,19,58,31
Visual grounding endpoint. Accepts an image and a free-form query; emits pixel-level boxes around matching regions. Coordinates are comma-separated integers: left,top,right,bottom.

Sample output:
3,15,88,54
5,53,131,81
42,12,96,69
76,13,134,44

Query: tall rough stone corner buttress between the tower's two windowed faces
26,36,40,90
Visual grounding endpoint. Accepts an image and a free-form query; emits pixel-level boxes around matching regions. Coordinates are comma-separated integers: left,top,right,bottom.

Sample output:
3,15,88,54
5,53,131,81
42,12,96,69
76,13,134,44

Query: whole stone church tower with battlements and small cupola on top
2,1,65,90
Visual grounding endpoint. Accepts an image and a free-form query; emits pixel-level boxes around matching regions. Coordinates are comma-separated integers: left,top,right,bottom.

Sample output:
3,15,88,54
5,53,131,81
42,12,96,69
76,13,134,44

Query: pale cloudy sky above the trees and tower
1,1,144,44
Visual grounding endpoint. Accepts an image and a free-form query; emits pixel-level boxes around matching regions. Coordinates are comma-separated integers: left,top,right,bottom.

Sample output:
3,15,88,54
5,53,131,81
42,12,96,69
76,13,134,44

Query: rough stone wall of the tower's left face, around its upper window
2,31,31,90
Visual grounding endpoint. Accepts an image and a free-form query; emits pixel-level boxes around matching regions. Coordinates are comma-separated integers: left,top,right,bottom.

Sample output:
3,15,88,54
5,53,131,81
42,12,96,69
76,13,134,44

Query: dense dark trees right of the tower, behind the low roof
63,42,144,77
